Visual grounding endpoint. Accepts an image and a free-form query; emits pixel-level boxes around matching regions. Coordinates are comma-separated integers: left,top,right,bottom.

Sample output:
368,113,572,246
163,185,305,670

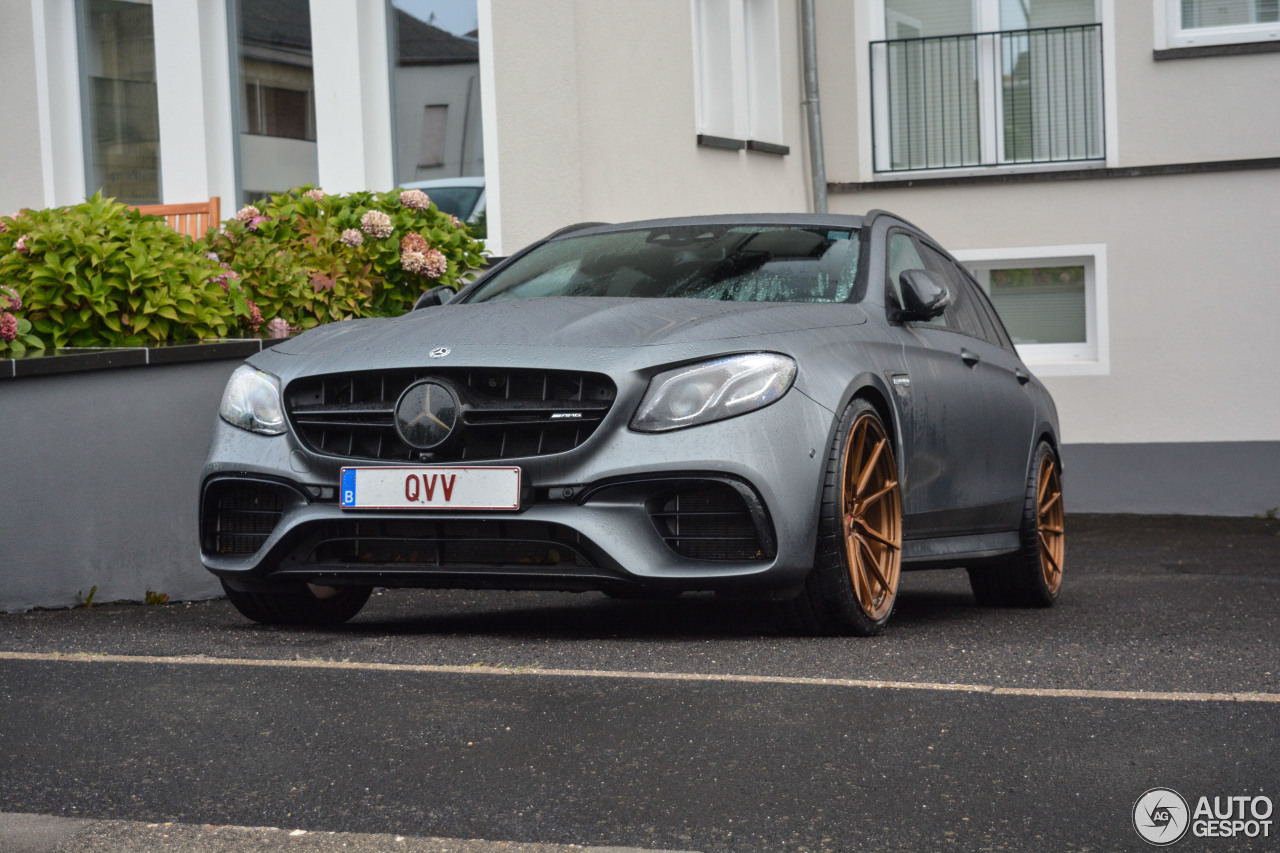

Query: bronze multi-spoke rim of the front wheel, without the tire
841,412,906,621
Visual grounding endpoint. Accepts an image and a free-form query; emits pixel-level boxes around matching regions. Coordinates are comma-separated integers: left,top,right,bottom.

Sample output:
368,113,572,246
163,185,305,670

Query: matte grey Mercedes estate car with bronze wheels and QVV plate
200,211,1064,634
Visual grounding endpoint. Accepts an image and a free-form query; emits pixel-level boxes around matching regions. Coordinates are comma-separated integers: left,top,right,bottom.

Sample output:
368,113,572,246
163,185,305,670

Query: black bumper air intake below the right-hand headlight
649,483,768,560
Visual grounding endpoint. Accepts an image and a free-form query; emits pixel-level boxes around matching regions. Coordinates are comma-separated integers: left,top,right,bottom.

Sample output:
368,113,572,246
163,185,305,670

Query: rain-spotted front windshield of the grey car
467,225,858,302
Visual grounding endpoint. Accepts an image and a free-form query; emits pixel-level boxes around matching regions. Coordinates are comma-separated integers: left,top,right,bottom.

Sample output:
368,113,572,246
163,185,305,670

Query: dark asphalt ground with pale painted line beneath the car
0,516,1280,853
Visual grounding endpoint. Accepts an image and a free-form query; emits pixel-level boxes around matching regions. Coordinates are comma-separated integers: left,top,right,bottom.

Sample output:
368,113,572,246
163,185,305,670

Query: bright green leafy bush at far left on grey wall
0,193,241,355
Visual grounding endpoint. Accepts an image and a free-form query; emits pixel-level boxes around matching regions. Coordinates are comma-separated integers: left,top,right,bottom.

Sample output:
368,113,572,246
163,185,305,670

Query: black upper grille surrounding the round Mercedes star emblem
284,368,617,462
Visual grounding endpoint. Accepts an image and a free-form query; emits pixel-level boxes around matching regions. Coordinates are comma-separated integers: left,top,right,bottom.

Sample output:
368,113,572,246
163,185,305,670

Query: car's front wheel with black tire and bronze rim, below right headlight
783,400,902,637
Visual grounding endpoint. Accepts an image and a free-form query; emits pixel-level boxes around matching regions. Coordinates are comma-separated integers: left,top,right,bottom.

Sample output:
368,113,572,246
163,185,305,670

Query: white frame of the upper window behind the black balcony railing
860,0,1121,182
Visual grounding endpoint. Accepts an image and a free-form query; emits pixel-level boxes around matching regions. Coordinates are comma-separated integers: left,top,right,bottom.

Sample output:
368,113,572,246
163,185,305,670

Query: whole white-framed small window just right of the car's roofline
954,245,1110,375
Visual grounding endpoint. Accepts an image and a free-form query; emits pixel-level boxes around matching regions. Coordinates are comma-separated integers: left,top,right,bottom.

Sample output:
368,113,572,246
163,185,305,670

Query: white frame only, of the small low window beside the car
951,243,1111,377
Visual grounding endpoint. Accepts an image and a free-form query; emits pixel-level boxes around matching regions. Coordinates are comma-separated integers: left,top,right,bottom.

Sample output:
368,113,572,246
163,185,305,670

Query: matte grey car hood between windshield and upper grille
273,297,867,356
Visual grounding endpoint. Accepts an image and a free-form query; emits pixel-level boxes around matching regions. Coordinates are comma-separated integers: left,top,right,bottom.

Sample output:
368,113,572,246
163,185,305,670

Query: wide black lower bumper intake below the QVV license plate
306,519,596,569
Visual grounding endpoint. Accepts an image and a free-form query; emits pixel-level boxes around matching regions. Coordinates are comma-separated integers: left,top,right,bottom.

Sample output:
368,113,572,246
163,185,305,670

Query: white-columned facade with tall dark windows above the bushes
0,0,484,213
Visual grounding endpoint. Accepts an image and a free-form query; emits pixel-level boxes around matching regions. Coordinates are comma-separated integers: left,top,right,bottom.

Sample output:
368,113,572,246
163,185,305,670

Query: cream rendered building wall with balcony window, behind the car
481,0,1280,515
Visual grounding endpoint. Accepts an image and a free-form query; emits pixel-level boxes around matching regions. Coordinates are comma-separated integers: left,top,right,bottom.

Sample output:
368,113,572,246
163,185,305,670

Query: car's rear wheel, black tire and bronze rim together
969,442,1066,607
